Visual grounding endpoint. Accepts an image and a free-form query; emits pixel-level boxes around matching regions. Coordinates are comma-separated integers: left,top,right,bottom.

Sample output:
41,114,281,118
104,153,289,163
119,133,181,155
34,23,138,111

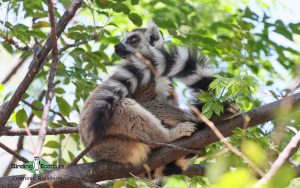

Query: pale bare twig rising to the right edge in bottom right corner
255,131,300,188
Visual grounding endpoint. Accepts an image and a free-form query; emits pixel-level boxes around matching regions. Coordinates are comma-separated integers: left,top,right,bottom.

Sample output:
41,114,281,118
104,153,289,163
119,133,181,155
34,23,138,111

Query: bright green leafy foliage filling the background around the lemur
0,0,300,188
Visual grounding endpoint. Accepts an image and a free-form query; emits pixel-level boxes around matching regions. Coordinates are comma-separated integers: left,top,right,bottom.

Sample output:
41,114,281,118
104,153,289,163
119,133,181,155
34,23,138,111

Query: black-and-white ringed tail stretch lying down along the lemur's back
89,59,154,138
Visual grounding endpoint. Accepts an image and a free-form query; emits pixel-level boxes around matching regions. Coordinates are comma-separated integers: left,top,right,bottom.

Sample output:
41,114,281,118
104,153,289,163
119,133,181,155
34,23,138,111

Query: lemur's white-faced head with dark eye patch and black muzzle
115,21,163,59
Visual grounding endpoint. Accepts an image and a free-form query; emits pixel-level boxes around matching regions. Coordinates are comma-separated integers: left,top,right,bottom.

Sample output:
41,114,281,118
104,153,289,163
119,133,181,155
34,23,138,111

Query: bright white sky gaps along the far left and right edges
0,0,300,174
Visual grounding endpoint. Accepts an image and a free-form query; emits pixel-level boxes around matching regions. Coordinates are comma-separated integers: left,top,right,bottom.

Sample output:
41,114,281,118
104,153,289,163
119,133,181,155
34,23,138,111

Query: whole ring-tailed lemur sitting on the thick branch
79,23,213,176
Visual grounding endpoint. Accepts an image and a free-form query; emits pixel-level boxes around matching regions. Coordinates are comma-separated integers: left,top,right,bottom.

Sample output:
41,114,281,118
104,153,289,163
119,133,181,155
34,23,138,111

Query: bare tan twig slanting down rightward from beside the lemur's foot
191,106,264,177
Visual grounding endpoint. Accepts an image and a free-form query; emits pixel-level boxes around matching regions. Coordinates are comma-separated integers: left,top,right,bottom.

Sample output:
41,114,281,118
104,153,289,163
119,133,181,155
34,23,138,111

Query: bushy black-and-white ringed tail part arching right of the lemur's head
150,47,214,111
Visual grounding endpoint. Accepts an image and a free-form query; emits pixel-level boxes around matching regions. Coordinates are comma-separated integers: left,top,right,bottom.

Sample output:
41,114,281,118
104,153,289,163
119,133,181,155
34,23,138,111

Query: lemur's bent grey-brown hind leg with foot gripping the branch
107,98,196,143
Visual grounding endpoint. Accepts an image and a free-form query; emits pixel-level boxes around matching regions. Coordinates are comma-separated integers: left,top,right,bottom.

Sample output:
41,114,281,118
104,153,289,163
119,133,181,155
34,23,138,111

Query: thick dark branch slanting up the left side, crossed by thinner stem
0,0,81,127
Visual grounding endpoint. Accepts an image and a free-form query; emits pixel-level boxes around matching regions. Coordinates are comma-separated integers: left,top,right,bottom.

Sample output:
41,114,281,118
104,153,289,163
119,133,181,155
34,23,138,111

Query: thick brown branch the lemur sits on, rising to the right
0,93,300,188
